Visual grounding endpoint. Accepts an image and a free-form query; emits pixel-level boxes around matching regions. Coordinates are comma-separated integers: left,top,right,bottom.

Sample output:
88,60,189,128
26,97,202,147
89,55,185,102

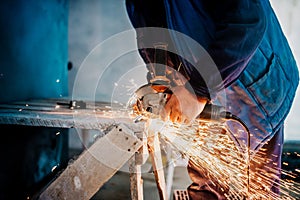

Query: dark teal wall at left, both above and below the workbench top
0,0,68,200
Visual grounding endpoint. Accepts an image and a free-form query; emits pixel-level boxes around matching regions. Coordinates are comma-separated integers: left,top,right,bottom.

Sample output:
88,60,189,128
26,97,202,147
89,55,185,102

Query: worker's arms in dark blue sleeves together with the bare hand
126,0,265,121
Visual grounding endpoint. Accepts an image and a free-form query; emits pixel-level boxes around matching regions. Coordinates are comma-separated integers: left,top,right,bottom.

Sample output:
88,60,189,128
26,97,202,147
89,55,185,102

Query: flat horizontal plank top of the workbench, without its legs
0,99,138,130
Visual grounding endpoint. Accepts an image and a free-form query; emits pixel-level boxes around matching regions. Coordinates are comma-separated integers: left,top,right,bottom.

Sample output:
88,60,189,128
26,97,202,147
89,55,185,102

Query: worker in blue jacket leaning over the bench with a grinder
126,0,299,199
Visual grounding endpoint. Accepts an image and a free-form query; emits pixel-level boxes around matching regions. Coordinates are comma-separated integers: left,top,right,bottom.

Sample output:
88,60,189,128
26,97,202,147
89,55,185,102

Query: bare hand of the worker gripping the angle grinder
160,86,207,124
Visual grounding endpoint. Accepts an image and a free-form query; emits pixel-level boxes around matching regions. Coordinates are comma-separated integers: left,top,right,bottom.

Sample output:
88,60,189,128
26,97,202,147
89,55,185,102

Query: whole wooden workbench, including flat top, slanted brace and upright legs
0,98,173,200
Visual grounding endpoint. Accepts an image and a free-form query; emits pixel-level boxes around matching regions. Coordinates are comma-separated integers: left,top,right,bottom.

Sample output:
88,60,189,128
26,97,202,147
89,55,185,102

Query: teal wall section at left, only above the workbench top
0,0,68,102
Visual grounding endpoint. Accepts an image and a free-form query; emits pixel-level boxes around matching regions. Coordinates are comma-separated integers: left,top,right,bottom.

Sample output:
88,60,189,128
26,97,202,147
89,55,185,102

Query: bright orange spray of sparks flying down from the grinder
144,119,300,200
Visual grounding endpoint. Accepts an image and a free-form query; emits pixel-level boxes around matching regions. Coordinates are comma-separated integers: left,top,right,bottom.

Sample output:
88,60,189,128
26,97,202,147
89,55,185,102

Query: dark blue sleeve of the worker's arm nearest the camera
165,0,266,97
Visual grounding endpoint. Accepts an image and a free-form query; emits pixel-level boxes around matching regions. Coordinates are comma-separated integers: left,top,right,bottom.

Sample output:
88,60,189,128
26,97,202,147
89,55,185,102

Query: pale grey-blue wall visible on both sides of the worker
69,0,300,145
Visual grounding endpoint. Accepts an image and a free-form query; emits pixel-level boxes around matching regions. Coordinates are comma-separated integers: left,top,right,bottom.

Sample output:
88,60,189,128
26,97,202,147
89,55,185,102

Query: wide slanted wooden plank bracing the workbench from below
39,125,142,200
